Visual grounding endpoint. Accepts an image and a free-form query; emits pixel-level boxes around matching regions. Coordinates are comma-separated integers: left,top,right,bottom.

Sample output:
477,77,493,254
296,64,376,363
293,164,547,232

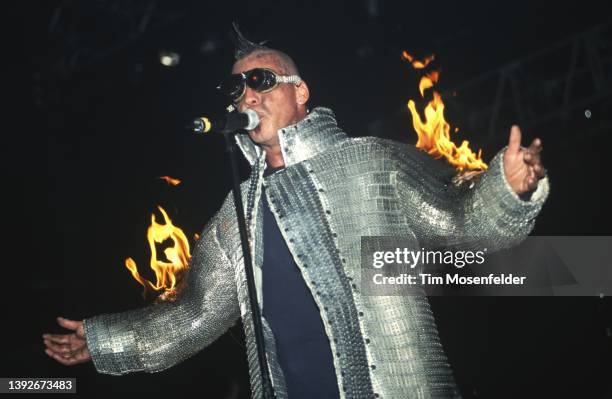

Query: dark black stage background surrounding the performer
0,0,612,398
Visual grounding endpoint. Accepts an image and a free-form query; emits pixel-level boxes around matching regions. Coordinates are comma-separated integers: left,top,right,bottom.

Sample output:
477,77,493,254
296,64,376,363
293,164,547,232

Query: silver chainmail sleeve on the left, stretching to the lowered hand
84,200,240,375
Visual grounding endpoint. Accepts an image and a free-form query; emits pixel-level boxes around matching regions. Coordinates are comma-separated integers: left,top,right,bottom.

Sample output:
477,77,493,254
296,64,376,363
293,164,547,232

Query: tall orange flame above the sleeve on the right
402,51,487,172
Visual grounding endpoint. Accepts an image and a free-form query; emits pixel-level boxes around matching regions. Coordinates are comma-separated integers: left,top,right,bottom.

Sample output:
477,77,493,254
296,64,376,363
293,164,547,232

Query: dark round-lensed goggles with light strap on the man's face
217,68,302,103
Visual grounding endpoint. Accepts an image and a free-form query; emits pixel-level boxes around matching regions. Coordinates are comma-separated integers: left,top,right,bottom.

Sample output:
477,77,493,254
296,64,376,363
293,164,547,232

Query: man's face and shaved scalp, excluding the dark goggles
232,55,305,148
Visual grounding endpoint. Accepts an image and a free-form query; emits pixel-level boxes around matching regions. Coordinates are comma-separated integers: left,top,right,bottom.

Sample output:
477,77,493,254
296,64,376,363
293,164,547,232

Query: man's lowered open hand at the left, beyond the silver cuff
43,317,91,366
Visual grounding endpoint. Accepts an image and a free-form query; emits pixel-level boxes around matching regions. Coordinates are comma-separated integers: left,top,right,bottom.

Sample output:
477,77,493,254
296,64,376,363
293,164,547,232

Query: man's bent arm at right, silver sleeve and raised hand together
398,127,548,250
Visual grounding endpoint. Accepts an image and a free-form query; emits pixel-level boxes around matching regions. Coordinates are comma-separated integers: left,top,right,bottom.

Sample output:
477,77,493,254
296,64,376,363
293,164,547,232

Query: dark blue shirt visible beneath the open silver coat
262,169,340,399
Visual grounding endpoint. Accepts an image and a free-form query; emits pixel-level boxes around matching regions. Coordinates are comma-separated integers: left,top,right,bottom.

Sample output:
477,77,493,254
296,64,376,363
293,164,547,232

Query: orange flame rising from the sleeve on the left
125,206,191,300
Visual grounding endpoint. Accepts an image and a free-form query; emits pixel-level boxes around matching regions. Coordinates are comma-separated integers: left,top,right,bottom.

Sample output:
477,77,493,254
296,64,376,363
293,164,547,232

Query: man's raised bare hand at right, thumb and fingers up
504,125,546,194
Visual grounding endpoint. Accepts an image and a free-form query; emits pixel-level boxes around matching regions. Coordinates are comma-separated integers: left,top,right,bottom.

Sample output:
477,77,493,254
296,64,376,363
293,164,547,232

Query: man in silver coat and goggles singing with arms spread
43,26,548,399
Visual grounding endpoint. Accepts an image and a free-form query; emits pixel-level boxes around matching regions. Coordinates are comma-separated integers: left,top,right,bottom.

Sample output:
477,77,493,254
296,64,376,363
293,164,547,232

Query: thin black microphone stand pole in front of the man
221,129,275,399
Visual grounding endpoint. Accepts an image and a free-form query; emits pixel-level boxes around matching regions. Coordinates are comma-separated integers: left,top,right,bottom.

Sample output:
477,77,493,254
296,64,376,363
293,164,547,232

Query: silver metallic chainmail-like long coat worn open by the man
85,108,548,399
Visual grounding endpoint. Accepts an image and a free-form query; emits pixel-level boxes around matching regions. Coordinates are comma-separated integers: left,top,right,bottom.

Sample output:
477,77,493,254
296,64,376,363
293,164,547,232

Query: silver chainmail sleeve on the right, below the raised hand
397,142,549,251
